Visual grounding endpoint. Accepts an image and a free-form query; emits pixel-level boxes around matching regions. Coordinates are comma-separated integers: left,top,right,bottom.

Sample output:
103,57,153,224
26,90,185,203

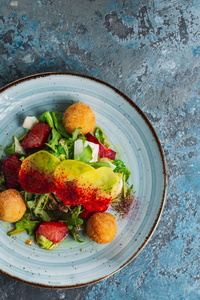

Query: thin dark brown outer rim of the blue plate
0,71,168,289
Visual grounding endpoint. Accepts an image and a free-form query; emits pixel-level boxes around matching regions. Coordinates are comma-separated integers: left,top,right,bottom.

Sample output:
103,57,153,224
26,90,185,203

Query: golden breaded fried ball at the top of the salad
63,102,96,134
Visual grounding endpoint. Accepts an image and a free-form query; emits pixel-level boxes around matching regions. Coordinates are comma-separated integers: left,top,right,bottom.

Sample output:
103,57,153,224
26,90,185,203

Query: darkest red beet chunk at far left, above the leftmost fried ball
3,154,22,188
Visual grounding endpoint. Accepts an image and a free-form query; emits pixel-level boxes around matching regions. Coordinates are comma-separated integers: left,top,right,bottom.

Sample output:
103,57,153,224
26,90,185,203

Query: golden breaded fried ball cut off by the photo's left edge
0,189,26,222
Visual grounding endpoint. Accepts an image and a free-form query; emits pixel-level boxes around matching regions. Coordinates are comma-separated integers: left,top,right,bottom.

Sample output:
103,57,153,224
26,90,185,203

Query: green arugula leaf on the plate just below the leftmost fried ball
7,213,40,236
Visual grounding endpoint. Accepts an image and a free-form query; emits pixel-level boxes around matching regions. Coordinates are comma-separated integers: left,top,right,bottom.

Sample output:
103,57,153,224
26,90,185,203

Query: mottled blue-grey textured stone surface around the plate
0,0,200,300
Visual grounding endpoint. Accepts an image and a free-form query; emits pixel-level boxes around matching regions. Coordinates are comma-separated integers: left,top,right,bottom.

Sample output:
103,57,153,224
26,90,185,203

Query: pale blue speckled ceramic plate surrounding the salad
0,73,167,288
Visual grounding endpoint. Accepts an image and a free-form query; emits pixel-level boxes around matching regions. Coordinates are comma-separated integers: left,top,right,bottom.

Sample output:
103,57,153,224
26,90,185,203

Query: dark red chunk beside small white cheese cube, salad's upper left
21,122,51,149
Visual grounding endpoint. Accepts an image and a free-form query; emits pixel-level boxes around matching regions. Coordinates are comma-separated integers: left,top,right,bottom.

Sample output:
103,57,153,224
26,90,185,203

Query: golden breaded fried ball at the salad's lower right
86,212,117,244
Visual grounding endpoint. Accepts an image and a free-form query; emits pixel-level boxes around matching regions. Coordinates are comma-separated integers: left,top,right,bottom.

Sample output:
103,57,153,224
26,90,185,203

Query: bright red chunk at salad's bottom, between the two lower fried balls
36,222,69,243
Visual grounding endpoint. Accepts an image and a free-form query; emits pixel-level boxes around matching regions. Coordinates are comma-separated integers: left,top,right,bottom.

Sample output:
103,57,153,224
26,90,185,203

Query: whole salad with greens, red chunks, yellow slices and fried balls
0,102,133,250
